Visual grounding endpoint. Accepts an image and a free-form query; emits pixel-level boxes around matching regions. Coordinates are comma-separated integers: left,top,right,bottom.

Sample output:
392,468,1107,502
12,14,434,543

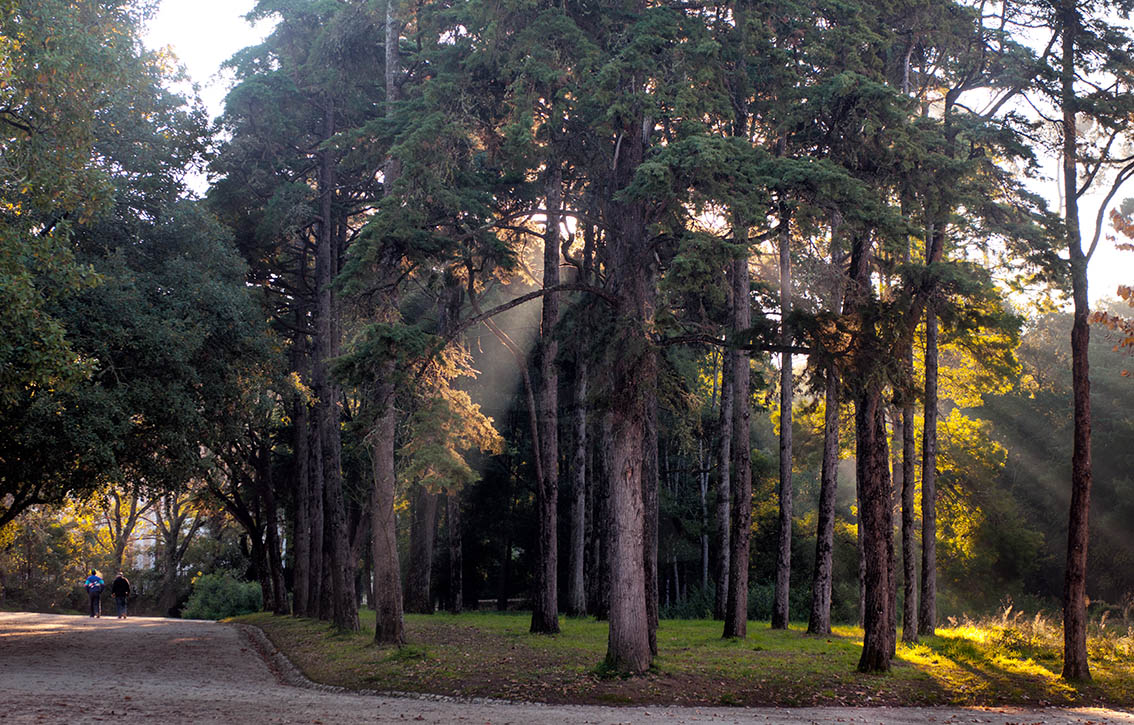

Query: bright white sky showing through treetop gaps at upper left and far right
145,0,1134,300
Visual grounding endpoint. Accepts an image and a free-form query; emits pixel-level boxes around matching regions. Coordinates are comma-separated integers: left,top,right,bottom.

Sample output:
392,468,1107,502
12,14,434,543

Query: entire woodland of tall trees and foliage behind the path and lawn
0,0,1134,677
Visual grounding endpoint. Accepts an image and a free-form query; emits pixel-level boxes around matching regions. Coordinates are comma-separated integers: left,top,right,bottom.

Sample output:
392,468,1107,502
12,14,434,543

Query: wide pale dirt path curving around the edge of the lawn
0,613,1134,725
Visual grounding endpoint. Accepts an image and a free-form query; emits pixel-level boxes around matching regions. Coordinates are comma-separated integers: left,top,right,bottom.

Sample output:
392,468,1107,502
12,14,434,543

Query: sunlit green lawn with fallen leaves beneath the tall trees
237,612,1134,707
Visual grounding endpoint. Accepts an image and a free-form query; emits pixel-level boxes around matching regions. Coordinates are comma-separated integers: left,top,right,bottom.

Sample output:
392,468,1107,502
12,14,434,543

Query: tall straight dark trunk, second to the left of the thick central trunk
531,167,562,634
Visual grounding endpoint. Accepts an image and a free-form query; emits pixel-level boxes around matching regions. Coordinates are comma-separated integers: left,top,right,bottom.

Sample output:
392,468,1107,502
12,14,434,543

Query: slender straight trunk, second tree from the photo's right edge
917,301,938,637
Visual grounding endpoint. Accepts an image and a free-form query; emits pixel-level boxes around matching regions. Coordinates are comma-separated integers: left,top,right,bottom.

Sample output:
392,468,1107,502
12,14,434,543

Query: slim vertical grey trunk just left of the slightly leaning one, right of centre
772,220,794,630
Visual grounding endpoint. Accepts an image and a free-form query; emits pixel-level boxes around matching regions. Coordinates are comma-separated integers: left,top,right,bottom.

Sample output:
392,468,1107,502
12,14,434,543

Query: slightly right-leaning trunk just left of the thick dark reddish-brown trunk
807,365,841,634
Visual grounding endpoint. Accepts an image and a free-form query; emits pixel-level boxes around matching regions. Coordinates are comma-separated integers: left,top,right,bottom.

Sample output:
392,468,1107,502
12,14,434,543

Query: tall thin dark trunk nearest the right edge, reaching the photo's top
1060,0,1091,681
